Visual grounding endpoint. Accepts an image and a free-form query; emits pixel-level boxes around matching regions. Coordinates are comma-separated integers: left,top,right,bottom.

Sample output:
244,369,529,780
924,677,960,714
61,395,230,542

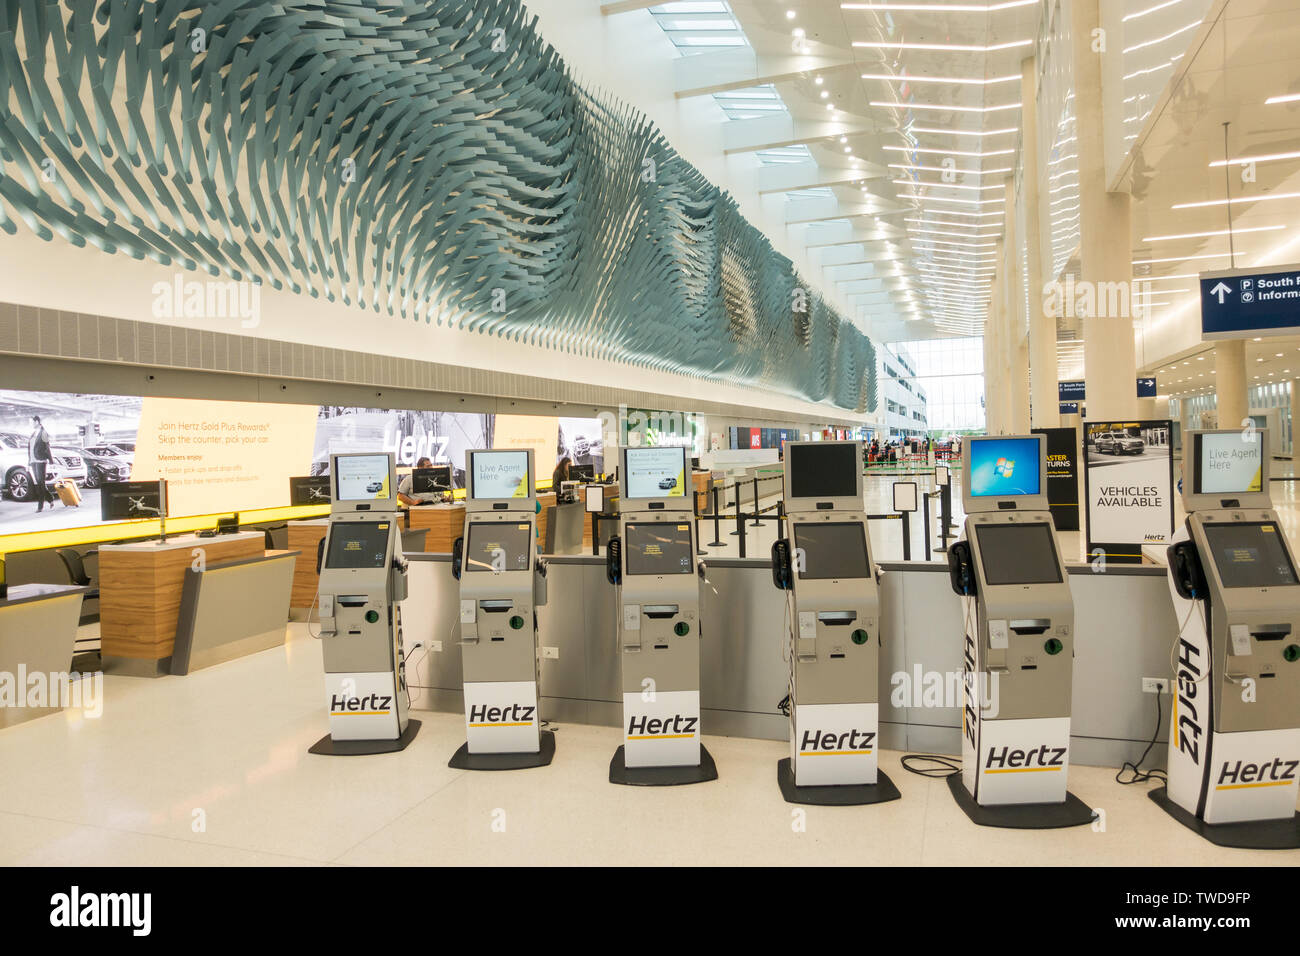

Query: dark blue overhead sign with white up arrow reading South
1200,265,1300,338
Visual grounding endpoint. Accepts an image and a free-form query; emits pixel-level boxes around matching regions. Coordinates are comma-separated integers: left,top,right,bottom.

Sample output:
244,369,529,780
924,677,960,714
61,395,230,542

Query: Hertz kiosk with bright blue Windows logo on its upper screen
948,434,1093,829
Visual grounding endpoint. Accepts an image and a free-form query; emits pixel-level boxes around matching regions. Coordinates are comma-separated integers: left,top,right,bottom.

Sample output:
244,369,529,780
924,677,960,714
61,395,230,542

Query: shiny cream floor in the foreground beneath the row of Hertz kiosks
0,624,1296,865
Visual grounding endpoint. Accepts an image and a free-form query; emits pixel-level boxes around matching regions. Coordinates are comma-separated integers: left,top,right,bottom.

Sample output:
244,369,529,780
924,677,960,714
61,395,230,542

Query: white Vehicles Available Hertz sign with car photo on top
1081,419,1174,562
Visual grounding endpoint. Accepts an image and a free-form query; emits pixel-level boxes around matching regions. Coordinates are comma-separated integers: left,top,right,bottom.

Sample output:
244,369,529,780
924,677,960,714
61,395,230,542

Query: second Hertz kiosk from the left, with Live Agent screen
449,449,555,770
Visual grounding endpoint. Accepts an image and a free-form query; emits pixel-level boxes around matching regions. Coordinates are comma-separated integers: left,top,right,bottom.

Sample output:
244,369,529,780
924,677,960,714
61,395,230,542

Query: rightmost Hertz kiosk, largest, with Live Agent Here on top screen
1151,429,1300,849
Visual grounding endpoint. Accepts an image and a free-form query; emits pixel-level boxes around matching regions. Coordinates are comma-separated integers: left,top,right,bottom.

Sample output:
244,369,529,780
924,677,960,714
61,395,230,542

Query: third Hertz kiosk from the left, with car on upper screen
606,447,718,786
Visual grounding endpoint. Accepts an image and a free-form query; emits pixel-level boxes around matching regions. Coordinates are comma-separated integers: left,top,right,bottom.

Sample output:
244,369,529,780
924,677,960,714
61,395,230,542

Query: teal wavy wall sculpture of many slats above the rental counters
0,0,876,411
